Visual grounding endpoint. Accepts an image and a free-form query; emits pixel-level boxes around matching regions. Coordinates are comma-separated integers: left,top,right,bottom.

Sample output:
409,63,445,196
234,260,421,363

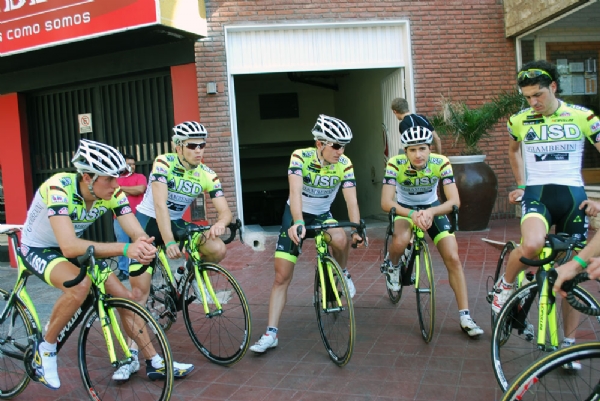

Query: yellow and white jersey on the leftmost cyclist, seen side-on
22,173,131,248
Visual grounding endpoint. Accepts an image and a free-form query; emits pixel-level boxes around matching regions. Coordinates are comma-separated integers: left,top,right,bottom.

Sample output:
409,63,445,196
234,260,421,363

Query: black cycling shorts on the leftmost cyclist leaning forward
19,244,109,287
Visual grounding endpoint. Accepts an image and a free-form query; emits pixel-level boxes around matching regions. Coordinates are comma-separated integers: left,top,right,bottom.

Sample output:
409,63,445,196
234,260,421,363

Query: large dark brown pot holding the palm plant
442,155,498,231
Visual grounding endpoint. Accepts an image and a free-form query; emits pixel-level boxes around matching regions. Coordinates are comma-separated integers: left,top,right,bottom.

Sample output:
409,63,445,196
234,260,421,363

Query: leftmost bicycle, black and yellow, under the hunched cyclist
0,226,174,401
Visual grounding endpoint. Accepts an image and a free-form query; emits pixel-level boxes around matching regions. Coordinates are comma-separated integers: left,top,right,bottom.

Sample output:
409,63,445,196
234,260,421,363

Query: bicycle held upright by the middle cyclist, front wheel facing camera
297,219,368,366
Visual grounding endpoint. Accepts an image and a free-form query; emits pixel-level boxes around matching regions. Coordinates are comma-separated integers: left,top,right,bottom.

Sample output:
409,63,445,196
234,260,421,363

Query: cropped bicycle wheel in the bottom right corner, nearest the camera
502,342,600,401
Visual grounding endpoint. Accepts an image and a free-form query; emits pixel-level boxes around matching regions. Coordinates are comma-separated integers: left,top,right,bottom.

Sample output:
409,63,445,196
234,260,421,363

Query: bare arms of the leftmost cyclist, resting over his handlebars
49,216,156,264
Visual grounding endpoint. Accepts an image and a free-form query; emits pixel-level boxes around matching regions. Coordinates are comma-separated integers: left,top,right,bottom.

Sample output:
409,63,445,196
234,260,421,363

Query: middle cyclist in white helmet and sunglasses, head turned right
250,114,363,353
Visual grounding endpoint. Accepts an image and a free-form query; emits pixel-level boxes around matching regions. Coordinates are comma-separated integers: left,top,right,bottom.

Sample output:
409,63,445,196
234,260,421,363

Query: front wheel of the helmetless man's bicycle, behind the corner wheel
492,282,600,391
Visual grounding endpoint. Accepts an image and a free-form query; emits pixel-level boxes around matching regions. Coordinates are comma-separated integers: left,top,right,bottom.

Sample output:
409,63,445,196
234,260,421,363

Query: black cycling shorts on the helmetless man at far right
521,184,589,241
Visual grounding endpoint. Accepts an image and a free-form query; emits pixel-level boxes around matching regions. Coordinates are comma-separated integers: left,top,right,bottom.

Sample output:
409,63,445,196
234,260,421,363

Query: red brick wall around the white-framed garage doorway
196,0,516,219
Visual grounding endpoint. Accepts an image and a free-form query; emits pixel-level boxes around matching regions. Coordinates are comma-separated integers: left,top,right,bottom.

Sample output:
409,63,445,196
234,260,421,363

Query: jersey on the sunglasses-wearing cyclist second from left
137,153,224,220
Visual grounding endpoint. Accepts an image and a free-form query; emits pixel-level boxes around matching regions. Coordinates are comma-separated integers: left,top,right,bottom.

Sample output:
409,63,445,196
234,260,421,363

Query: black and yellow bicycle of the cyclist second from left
146,219,251,366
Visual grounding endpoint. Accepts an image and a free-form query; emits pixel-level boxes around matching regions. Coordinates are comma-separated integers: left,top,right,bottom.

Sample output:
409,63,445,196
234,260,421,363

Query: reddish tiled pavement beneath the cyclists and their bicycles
0,219,519,401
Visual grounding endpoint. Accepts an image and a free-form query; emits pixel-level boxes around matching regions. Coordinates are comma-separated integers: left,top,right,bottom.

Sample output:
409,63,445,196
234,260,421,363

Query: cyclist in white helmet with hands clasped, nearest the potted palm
381,126,483,337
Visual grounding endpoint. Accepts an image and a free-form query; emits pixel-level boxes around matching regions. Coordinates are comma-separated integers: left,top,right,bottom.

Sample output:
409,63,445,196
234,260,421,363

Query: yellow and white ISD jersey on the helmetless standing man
507,101,600,186
